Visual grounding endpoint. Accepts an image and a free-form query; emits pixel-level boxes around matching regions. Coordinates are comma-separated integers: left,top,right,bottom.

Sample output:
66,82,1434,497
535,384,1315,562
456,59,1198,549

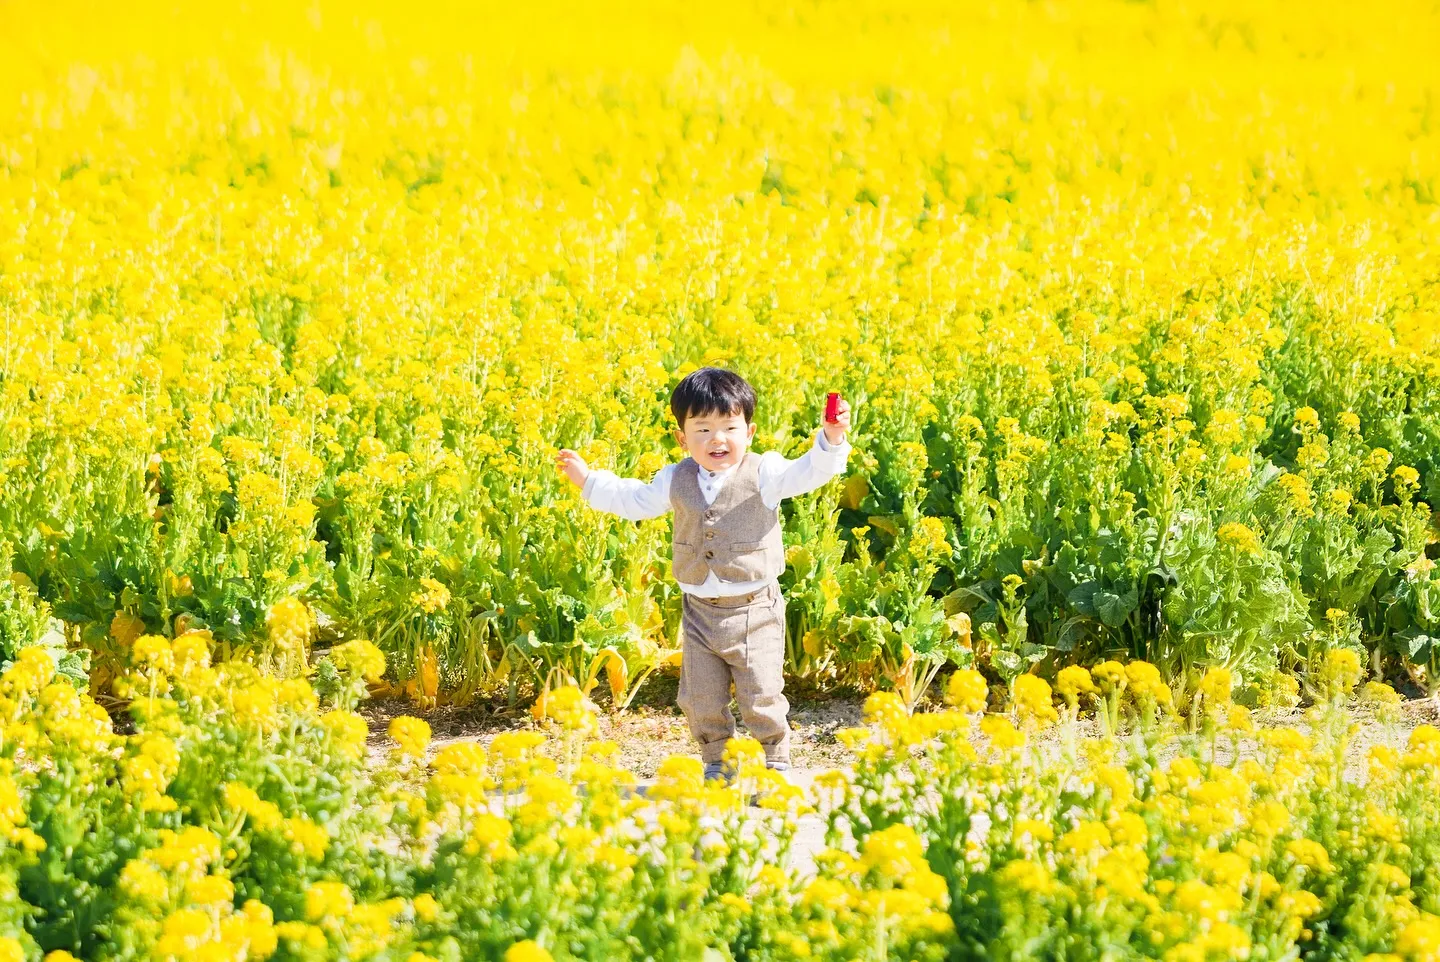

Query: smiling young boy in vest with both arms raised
557,367,850,779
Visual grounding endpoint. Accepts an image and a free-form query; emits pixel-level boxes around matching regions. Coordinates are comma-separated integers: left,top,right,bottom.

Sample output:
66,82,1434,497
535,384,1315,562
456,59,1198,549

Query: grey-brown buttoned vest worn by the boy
670,451,785,585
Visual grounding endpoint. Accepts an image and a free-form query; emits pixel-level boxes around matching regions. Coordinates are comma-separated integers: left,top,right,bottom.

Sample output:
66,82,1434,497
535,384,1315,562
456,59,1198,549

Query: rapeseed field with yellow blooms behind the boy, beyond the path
0,1,1440,703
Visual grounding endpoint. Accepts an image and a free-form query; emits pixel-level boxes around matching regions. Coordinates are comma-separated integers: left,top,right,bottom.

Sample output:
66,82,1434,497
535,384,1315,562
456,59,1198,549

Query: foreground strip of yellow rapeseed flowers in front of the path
8,616,1440,962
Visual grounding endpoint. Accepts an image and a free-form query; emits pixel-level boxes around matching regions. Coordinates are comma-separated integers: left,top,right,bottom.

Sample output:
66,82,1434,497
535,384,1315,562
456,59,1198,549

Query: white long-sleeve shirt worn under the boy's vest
580,431,850,598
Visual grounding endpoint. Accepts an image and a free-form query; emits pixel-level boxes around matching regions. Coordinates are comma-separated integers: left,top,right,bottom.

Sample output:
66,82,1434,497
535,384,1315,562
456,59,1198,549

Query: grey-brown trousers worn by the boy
678,583,791,765
